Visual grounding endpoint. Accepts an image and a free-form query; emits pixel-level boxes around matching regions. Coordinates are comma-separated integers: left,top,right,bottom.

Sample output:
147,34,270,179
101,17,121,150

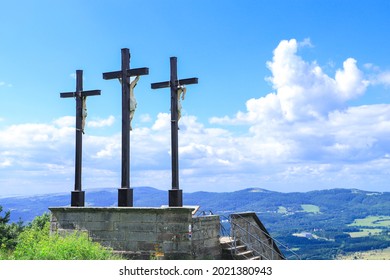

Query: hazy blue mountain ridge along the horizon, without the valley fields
0,187,390,223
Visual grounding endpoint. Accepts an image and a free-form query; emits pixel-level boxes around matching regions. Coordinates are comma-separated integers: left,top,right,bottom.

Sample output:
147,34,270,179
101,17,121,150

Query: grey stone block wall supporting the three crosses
50,207,220,259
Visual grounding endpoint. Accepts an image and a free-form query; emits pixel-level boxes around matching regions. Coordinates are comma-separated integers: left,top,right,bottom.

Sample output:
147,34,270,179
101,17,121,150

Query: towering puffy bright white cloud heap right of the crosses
210,39,369,123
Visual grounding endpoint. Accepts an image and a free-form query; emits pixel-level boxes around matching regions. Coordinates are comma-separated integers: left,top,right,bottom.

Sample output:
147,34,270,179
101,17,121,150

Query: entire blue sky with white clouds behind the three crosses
0,0,390,196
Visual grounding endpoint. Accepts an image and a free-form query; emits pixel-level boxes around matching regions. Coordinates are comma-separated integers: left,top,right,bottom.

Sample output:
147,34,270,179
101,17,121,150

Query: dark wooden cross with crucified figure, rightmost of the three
151,57,198,207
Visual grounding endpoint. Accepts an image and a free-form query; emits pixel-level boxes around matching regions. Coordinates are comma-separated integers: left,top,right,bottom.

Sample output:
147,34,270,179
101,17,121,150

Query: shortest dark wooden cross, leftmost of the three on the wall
60,70,100,207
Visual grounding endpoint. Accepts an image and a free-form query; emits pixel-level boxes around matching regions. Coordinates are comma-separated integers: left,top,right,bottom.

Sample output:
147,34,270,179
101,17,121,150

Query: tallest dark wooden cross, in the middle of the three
103,48,149,207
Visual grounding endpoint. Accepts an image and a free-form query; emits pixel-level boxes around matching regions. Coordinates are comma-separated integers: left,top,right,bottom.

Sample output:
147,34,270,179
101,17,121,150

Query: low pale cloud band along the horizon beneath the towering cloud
0,105,390,197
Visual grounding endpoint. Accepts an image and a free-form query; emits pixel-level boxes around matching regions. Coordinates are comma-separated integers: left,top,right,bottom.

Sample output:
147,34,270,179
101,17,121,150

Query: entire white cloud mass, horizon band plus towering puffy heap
0,40,390,197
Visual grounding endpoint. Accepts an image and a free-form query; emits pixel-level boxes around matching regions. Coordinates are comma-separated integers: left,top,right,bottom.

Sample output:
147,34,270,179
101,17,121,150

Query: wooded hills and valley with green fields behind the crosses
0,187,390,259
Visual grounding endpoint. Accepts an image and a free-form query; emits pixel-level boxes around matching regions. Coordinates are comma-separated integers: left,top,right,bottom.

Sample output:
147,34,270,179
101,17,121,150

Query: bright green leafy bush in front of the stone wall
11,217,120,260
